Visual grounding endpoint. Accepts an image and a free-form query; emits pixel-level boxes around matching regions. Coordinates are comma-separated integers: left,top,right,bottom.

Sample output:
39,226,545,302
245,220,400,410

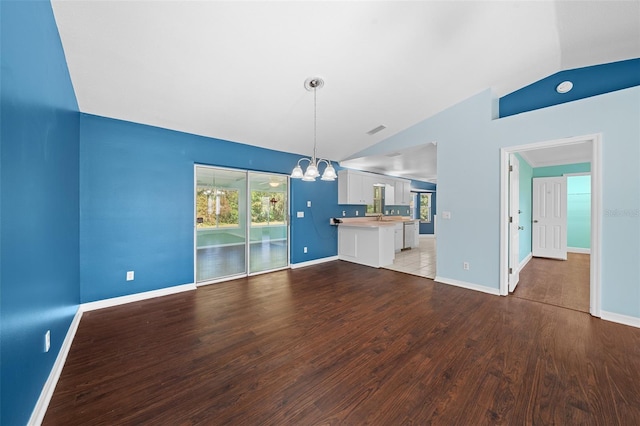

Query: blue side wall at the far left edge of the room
0,1,80,425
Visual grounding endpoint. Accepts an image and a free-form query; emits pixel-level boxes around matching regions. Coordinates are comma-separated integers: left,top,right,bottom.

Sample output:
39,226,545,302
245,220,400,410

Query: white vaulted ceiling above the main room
52,0,640,179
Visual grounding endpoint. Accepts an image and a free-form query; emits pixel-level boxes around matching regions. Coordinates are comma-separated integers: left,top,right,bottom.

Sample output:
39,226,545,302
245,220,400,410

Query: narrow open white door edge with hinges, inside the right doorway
509,154,520,291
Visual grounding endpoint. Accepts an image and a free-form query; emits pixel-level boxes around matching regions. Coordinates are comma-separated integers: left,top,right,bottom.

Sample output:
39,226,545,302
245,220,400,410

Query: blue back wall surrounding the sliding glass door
80,114,344,303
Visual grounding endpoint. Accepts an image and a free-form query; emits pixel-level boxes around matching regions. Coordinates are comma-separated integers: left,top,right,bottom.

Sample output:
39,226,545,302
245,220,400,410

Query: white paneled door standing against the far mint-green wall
532,176,567,260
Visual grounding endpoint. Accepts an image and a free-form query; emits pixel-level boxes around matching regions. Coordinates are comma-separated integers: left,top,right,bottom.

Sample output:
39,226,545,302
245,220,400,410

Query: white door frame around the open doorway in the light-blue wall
500,133,602,317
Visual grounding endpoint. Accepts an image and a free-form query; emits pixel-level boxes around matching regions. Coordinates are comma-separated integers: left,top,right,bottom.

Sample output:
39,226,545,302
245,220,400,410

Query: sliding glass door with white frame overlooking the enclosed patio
195,166,289,283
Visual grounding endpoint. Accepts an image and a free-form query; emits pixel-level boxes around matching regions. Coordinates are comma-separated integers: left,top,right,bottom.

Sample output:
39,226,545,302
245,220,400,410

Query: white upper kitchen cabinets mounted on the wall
338,169,411,206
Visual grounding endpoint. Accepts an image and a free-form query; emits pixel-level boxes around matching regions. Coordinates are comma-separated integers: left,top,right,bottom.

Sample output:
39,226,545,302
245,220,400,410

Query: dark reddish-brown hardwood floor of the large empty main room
43,261,640,425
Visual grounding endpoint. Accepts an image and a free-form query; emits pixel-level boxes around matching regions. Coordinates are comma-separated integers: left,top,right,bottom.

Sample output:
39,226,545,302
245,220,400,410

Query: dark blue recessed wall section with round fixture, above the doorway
499,58,640,117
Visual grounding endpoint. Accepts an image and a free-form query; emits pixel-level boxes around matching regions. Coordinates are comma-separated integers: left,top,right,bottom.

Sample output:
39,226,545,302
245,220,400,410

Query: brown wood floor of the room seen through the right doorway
513,253,591,312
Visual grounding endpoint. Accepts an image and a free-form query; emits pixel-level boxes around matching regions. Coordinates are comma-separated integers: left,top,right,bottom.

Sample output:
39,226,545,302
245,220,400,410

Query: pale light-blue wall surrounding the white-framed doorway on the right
358,87,640,318
